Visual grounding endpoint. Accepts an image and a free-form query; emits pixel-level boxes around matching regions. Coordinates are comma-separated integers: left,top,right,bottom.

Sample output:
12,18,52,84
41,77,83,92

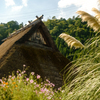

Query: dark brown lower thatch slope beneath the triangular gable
0,45,69,88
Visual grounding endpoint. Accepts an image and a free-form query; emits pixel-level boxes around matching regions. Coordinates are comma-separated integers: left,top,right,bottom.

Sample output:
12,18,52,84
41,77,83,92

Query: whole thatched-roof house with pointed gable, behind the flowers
0,16,69,87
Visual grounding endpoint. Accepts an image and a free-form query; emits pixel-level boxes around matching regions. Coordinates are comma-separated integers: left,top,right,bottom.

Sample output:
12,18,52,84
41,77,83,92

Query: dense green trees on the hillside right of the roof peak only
44,16,95,60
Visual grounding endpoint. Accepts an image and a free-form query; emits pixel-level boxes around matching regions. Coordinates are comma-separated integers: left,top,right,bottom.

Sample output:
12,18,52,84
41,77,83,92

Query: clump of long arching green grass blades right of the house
61,36,100,100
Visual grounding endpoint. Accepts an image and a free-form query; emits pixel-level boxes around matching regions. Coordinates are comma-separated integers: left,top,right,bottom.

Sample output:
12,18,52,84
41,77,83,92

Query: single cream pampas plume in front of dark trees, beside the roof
59,33,84,49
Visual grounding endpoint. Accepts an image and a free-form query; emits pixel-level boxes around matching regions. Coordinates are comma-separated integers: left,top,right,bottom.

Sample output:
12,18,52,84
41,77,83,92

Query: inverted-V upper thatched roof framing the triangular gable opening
0,16,58,59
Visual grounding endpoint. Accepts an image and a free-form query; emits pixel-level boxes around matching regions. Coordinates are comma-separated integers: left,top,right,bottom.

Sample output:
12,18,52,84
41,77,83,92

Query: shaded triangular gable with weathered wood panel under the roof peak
16,21,58,51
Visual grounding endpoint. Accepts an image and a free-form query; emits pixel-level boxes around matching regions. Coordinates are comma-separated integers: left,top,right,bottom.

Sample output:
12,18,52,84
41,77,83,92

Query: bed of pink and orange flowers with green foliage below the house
0,69,60,100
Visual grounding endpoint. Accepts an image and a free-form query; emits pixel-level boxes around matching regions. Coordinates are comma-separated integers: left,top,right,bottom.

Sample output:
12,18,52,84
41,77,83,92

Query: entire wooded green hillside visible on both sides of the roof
0,16,95,60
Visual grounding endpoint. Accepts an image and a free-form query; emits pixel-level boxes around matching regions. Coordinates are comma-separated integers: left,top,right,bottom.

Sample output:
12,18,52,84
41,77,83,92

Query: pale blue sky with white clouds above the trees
0,0,98,24
